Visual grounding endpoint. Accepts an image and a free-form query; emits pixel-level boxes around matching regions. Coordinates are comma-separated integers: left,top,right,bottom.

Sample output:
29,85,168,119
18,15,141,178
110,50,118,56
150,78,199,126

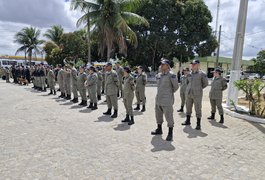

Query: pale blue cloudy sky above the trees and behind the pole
0,0,265,59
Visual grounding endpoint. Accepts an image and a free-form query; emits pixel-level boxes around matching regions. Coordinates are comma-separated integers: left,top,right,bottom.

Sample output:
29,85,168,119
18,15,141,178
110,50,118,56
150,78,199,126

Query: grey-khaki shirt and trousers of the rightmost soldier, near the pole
209,76,227,115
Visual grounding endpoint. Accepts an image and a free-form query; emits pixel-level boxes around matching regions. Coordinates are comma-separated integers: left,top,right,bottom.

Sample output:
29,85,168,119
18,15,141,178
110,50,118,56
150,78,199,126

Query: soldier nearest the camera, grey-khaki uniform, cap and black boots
151,59,179,141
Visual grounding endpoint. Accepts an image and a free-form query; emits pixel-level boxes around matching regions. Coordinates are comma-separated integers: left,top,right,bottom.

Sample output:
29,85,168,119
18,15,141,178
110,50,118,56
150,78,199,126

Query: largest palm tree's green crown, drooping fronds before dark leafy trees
72,0,149,61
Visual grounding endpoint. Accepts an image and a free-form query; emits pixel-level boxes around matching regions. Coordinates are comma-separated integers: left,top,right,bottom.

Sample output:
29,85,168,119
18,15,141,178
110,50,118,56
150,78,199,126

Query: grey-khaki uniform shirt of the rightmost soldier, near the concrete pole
209,76,227,99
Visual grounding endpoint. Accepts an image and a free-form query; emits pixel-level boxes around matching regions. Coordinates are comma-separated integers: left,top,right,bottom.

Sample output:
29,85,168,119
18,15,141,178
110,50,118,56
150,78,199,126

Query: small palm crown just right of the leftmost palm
44,25,64,46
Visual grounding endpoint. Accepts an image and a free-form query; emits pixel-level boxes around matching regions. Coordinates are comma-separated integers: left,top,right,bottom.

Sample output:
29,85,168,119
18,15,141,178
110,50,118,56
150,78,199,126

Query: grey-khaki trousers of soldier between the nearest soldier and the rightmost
186,96,202,118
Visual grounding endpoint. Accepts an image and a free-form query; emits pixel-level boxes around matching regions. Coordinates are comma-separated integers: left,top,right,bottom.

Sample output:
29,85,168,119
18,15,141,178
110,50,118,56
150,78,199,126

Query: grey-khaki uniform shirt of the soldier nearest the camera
156,72,179,106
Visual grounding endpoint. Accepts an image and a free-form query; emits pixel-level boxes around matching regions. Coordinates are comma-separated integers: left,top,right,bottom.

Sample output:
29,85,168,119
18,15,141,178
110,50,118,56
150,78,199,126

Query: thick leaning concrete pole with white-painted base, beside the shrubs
226,0,248,107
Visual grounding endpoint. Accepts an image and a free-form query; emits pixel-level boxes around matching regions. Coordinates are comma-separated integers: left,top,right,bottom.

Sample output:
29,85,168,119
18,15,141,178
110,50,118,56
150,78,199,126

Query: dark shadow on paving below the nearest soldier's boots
151,135,175,152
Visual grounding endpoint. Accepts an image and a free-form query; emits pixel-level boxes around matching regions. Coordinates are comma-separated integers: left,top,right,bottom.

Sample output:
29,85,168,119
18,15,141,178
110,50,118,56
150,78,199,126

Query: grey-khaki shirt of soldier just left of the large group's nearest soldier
105,70,119,96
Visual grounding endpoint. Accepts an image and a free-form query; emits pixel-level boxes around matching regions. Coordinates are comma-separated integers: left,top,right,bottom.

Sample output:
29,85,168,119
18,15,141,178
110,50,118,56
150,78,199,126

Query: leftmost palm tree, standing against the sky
14,27,44,66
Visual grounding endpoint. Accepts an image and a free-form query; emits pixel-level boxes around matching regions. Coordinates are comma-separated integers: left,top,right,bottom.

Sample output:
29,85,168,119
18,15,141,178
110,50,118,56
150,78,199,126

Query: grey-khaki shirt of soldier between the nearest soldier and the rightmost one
186,70,208,97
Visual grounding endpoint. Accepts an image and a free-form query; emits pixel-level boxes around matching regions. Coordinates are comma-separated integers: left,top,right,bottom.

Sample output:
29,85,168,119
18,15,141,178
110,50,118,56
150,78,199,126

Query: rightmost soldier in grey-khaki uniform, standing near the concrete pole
208,68,227,124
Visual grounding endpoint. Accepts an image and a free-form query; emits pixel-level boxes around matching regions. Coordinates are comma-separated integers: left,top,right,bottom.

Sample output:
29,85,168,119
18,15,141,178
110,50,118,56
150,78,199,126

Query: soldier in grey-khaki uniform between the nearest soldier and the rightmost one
182,60,208,130
